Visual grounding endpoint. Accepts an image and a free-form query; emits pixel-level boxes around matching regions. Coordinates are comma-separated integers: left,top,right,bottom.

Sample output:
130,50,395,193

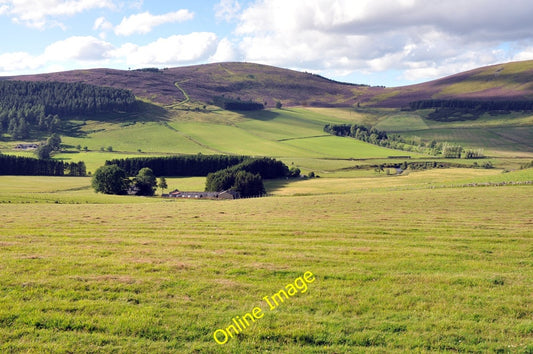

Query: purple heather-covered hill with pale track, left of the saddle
4,63,376,107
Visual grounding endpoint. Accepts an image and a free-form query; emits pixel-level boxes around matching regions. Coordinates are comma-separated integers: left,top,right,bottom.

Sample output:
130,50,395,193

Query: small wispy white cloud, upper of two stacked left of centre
115,9,194,36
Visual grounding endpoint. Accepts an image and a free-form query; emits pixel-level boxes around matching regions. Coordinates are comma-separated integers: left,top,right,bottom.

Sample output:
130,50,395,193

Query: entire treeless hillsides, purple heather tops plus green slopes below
0,61,533,176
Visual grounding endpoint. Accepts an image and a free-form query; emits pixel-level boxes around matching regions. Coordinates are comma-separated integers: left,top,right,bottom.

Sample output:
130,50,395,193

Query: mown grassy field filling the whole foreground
0,182,533,353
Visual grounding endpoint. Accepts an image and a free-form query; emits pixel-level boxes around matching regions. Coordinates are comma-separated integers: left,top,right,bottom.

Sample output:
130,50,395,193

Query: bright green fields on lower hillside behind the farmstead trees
4,106,533,173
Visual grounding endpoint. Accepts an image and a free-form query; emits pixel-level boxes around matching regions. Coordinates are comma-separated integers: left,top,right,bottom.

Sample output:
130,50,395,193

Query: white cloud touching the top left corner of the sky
0,0,114,29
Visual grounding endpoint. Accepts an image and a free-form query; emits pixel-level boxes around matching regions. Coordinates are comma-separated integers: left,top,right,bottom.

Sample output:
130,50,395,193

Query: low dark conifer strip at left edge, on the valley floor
0,154,86,176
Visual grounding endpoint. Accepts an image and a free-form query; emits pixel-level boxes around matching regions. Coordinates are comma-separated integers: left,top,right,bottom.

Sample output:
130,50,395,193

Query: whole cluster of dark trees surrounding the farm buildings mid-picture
93,155,288,197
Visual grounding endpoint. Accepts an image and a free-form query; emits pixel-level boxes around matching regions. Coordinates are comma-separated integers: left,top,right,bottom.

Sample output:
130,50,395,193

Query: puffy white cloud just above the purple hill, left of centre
111,32,218,67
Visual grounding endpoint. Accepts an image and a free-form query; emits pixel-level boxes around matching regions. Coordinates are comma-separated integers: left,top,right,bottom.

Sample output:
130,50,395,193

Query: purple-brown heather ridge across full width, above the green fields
1,60,533,108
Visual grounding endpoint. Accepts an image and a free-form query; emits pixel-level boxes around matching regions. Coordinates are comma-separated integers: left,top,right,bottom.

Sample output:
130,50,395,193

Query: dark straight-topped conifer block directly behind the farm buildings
105,154,249,177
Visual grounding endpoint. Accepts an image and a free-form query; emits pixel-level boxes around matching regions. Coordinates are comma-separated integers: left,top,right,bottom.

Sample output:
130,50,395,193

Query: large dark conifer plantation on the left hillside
0,81,137,139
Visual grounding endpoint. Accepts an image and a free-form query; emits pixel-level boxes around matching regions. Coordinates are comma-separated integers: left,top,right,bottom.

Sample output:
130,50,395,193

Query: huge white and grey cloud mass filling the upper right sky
235,0,533,80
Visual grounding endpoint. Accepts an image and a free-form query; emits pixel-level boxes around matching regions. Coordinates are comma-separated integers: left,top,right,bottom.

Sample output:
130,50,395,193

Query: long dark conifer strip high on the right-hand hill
409,100,533,111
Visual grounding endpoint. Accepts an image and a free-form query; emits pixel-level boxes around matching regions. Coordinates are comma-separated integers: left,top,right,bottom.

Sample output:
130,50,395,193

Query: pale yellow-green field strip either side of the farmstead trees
0,168,533,204
